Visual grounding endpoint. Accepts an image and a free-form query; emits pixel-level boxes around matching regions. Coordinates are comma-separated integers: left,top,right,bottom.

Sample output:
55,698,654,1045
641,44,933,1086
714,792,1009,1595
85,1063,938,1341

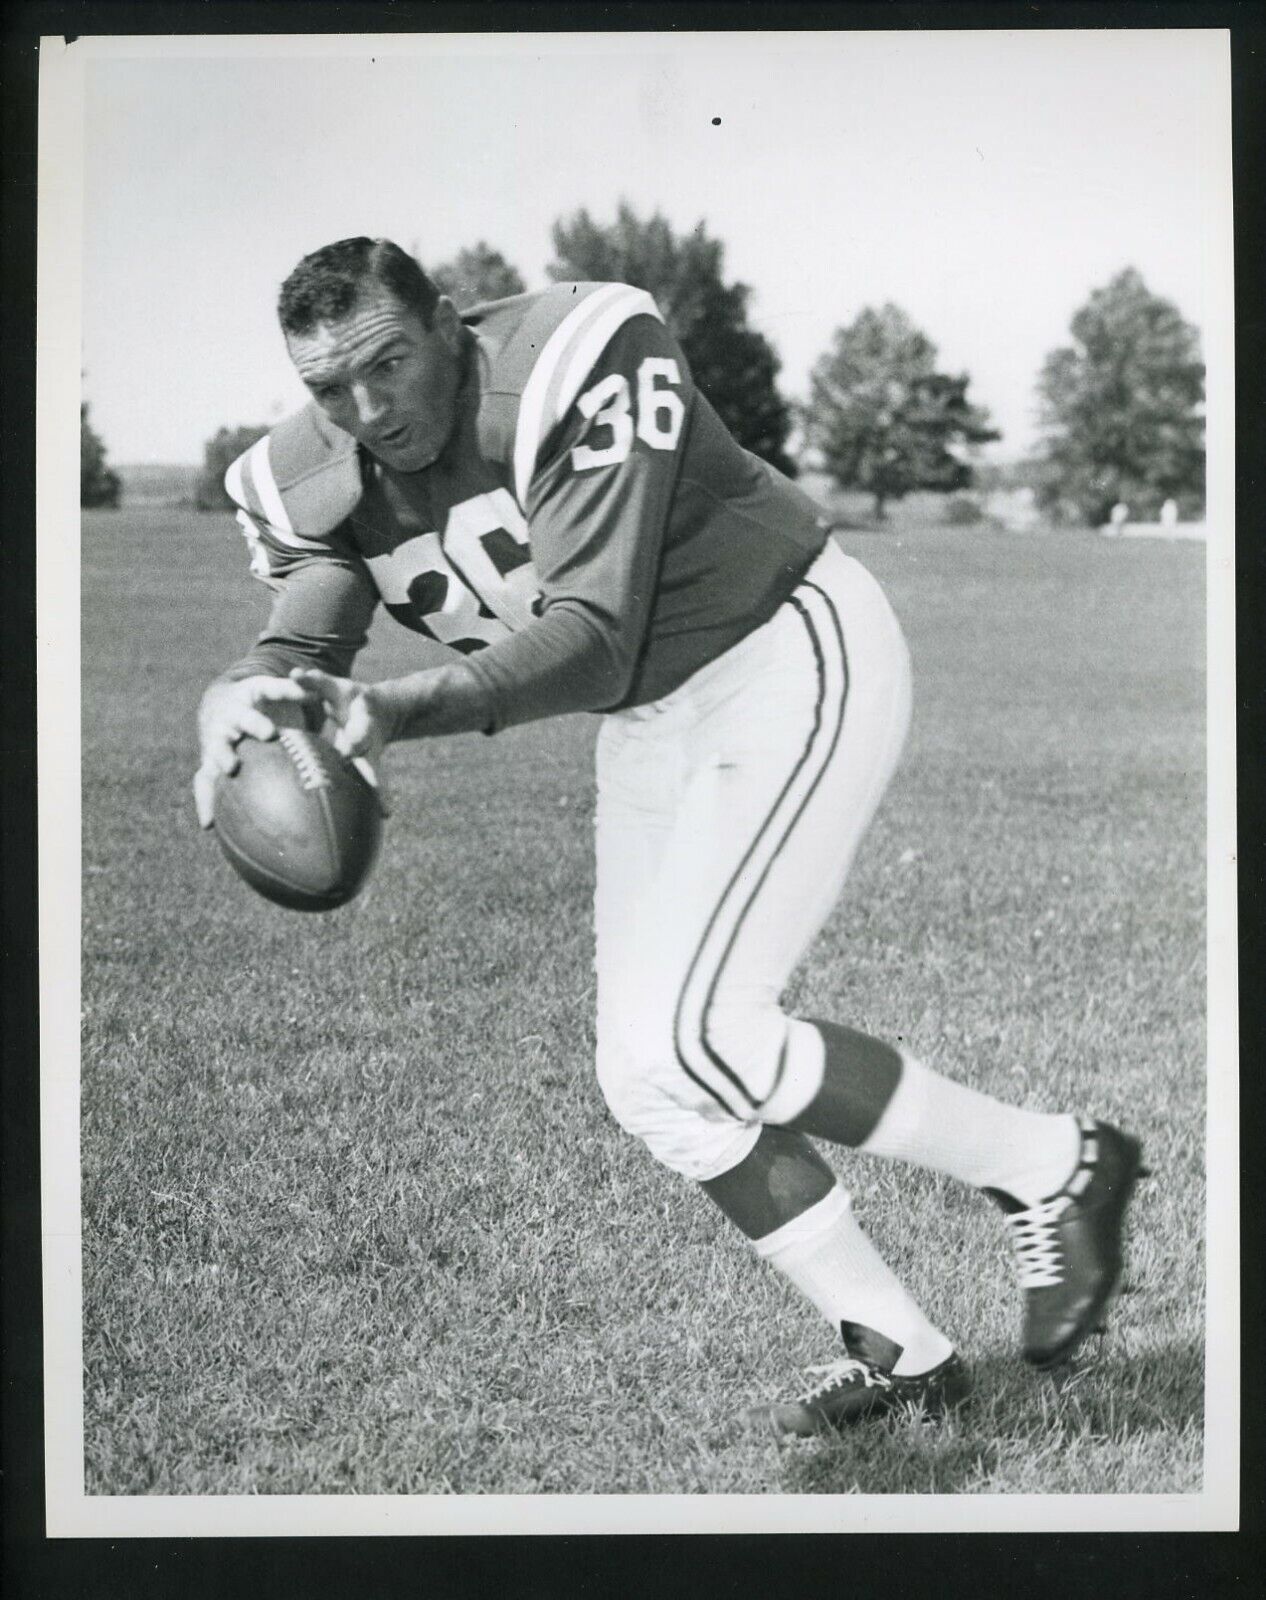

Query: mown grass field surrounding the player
82,509,1205,1494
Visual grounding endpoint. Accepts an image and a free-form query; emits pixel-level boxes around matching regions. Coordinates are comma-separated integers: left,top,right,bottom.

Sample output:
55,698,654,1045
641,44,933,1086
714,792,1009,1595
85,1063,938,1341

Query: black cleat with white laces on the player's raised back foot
989,1120,1146,1371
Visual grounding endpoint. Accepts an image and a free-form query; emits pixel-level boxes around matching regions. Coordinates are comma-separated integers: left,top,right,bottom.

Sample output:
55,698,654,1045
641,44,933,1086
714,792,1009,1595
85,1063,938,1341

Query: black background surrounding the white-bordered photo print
0,0,1266,1600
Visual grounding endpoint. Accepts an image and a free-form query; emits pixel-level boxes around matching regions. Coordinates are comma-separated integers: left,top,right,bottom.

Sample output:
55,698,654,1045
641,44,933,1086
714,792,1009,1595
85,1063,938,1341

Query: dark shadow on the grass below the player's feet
783,1341,1204,1494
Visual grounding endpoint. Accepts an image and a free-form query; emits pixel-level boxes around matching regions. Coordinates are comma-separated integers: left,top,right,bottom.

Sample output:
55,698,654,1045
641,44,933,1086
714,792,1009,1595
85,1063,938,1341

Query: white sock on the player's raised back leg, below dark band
861,1053,1082,1206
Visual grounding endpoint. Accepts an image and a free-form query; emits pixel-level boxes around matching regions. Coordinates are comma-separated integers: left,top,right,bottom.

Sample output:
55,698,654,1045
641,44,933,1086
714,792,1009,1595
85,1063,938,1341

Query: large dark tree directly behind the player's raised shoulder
546,205,795,477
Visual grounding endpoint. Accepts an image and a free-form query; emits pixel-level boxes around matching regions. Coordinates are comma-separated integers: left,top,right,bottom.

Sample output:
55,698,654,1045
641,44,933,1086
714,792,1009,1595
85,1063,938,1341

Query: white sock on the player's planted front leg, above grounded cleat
752,1184,954,1376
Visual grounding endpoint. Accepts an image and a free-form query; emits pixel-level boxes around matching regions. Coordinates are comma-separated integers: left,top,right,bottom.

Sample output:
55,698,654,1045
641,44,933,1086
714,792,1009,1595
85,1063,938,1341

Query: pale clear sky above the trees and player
70,29,1231,462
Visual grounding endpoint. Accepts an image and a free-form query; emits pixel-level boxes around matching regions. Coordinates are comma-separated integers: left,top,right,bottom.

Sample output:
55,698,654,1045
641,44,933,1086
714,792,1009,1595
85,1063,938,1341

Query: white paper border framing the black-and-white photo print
37,29,1239,1539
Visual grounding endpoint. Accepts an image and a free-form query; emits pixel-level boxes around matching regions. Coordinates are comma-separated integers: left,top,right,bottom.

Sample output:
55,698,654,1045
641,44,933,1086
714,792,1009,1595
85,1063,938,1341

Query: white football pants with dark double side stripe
595,541,911,1181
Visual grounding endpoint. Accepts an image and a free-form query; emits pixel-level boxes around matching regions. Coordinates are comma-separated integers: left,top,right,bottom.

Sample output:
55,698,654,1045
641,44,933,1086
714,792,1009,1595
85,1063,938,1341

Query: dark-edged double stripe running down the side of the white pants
674,582,848,1120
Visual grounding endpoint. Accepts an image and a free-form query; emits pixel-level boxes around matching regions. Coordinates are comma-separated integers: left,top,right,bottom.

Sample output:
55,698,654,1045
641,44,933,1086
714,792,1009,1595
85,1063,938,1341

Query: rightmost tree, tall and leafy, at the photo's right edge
1037,267,1205,526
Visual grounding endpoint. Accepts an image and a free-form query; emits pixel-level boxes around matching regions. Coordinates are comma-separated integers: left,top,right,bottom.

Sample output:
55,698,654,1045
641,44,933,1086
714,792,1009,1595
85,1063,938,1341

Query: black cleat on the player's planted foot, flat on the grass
749,1322,970,1438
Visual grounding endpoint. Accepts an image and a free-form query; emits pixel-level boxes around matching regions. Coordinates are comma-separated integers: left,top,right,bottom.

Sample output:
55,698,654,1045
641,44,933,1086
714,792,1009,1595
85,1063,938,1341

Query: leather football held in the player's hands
214,728,383,910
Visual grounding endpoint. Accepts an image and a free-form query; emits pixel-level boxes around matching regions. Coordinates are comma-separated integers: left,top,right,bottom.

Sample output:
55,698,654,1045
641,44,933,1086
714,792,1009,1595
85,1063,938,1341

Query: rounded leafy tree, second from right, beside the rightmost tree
805,304,1000,520
